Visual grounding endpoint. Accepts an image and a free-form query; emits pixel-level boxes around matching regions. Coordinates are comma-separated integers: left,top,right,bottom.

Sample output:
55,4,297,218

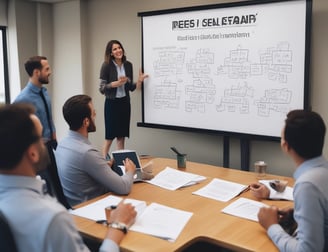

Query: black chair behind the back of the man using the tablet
38,144,71,209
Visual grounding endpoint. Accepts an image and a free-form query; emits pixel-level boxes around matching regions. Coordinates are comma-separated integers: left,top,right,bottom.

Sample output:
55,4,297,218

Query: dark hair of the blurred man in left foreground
0,103,40,170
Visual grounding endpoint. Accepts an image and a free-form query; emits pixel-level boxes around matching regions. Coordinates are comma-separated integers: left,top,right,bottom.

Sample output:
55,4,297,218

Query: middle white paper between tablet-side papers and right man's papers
193,178,248,202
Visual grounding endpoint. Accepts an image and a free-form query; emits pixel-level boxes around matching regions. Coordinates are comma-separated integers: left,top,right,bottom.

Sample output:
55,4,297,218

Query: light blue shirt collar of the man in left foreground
0,174,47,195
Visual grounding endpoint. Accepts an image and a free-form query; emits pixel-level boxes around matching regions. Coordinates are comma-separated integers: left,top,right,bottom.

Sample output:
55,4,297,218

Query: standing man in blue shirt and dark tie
14,56,57,148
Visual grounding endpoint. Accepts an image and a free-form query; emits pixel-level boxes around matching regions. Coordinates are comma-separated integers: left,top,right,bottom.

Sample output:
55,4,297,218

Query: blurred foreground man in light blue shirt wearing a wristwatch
0,104,136,252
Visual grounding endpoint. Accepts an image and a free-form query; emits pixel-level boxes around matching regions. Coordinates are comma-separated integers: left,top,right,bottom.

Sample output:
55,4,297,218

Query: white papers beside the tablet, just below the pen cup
146,167,206,190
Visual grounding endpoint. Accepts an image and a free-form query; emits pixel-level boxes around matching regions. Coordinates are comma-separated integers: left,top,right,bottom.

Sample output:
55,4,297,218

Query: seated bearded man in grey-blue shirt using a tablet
55,95,136,206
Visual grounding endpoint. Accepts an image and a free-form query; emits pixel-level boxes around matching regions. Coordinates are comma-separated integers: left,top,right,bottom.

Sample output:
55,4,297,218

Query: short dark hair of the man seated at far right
284,110,326,159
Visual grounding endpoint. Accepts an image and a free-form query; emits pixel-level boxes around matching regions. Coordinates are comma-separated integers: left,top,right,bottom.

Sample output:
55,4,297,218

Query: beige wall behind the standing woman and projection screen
7,0,328,175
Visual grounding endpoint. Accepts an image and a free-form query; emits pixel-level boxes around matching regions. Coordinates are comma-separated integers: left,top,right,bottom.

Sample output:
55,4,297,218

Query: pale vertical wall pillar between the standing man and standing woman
52,1,84,139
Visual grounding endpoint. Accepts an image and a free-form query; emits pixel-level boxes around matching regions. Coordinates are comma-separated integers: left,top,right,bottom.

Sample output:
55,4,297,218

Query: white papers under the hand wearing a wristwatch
71,195,193,241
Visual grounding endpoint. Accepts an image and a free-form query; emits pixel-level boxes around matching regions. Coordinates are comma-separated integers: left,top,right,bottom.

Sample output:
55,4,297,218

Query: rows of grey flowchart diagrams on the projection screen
153,42,293,116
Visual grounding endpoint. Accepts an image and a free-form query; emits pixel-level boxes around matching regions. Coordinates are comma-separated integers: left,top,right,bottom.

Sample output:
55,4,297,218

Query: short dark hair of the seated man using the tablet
63,95,92,130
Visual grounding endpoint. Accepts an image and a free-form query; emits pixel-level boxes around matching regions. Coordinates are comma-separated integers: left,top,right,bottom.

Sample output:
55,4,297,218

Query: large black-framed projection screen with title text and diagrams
138,0,312,138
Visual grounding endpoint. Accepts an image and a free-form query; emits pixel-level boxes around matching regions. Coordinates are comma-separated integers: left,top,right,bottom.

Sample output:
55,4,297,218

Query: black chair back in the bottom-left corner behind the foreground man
0,211,18,252
